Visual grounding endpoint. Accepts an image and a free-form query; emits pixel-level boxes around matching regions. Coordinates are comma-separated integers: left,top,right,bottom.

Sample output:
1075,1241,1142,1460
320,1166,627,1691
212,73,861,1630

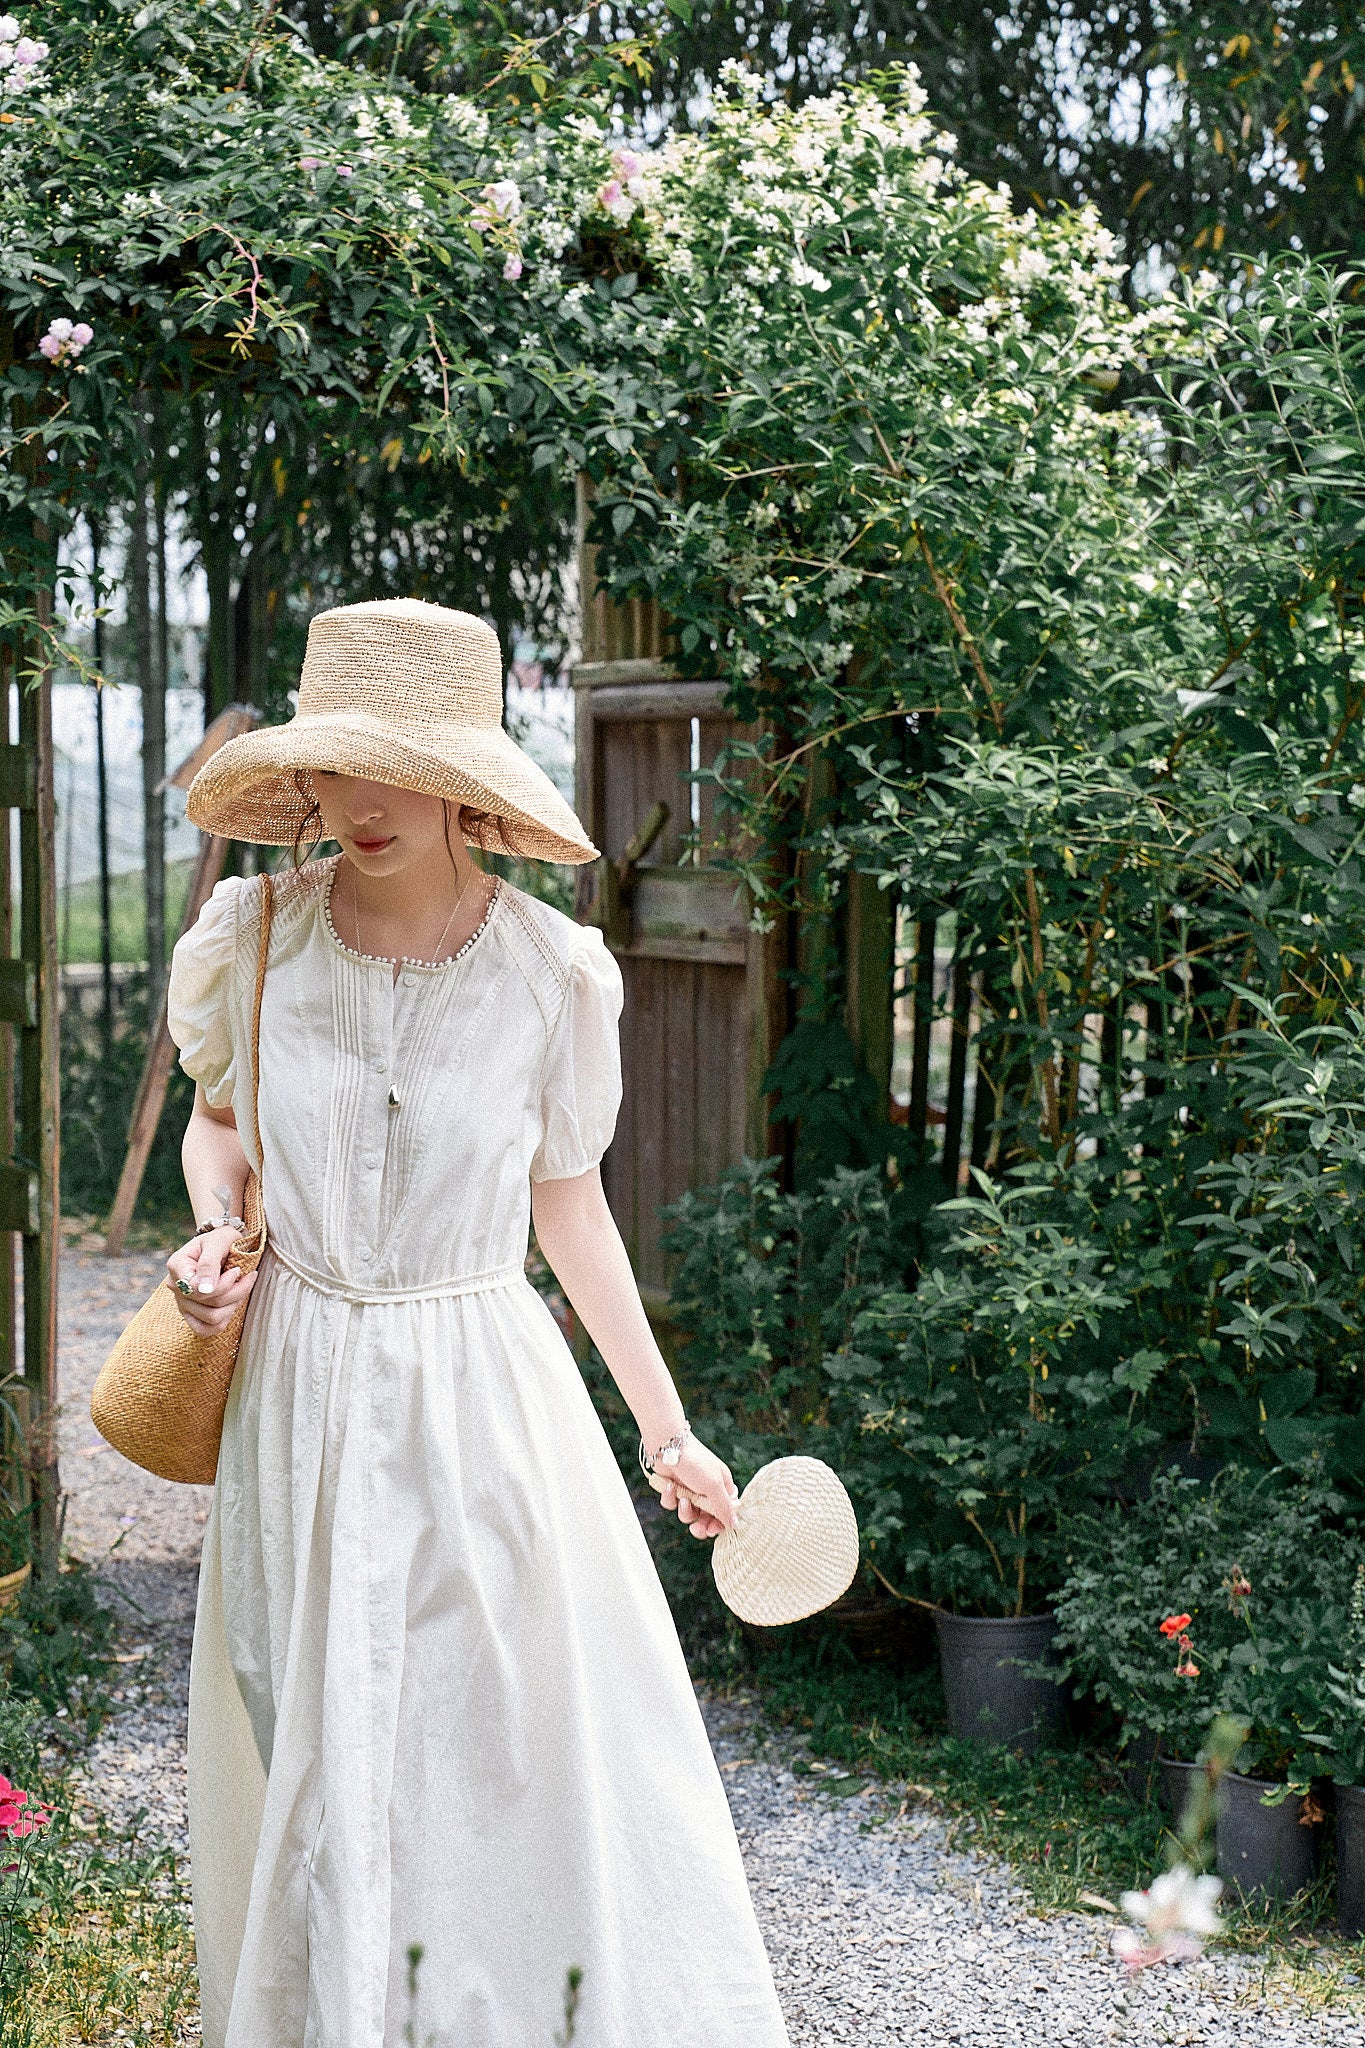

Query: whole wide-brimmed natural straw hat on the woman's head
186,598,598,862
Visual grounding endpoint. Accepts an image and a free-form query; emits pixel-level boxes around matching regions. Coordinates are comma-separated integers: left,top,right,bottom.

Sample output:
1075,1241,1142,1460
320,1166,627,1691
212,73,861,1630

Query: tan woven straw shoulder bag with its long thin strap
90,874,272,1487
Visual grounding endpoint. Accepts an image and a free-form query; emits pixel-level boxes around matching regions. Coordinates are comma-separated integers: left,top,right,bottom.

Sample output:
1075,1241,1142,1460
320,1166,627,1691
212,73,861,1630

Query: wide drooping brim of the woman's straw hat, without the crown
186,711,598,864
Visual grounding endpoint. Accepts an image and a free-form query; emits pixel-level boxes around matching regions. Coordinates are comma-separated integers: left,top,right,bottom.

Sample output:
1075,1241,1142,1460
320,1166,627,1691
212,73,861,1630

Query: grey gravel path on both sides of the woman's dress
61,1245,1365,2048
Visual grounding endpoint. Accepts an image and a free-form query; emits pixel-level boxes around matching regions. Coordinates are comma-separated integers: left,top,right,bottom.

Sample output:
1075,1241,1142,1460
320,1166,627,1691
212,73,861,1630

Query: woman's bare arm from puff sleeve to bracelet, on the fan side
530,1167,684,1450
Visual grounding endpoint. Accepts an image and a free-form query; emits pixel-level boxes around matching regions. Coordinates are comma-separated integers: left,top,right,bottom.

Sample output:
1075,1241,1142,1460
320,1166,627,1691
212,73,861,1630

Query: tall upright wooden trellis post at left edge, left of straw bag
18,638,61,1577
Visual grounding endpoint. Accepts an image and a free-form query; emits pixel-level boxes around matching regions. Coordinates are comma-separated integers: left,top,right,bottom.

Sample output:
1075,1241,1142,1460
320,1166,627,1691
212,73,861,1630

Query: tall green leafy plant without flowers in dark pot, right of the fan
855,1174,1150,1749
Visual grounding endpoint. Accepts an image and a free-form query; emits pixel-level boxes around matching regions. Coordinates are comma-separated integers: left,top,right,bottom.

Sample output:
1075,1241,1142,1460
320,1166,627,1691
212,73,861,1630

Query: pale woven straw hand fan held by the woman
649,1458,857,1628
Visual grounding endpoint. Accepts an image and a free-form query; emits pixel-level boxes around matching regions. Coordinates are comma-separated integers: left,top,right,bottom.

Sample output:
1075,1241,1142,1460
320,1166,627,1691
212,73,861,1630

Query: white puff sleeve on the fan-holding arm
530,928,624,1180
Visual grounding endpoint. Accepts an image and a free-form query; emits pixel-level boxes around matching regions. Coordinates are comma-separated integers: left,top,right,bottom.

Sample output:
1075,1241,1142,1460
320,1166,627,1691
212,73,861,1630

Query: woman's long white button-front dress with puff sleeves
170,860,788,2048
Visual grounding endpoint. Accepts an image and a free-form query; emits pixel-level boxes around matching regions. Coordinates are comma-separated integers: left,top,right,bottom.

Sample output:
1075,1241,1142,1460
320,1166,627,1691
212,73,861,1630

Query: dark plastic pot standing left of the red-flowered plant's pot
933,1612,1064,1755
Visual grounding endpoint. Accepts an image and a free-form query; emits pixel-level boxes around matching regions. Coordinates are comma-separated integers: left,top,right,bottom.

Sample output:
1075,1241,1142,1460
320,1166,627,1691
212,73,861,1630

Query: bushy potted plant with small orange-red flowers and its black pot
1056,1466,1361,1894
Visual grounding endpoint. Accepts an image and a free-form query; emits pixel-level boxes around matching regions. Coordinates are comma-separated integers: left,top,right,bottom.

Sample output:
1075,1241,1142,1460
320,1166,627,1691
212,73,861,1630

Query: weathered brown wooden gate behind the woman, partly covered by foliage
573,487,786,1315
